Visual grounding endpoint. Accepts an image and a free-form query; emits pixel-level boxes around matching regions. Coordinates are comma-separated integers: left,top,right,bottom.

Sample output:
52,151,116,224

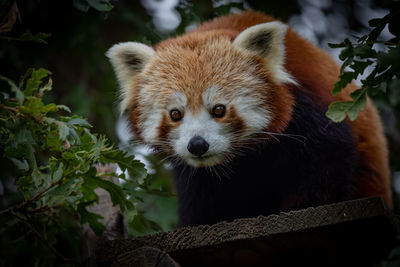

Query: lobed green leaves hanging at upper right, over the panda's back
326,1,400,122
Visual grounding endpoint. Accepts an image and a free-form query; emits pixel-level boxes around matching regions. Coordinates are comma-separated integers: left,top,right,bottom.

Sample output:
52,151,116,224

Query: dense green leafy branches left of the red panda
0,69,155,265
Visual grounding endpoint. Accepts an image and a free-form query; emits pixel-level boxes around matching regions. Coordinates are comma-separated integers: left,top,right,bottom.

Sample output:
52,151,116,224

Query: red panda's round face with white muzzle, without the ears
136,38,272,167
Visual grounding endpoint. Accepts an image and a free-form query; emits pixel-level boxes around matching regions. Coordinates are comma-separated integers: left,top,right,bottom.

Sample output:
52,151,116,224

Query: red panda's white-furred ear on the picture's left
106,42,155,113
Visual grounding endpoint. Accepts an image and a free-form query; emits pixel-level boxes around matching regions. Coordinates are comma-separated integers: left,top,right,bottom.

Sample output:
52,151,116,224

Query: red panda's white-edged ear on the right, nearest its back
233,21,295,83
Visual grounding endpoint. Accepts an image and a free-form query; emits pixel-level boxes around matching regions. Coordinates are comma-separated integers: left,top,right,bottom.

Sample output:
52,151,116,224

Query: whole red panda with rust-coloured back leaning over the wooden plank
107,11,391,226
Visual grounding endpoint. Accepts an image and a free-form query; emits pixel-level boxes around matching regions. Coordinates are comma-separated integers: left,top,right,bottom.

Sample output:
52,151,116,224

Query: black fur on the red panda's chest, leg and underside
174,91,360,226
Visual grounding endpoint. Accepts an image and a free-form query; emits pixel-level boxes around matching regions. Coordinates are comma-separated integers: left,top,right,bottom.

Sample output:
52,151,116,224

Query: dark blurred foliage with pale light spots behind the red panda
0,0,400,235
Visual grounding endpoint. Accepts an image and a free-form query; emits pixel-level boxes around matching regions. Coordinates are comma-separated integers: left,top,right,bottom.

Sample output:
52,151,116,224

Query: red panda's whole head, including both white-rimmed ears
107,22,294,167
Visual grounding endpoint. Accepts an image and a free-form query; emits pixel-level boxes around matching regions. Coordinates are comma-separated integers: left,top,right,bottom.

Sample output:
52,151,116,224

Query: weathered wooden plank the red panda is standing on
96,198,399,266
